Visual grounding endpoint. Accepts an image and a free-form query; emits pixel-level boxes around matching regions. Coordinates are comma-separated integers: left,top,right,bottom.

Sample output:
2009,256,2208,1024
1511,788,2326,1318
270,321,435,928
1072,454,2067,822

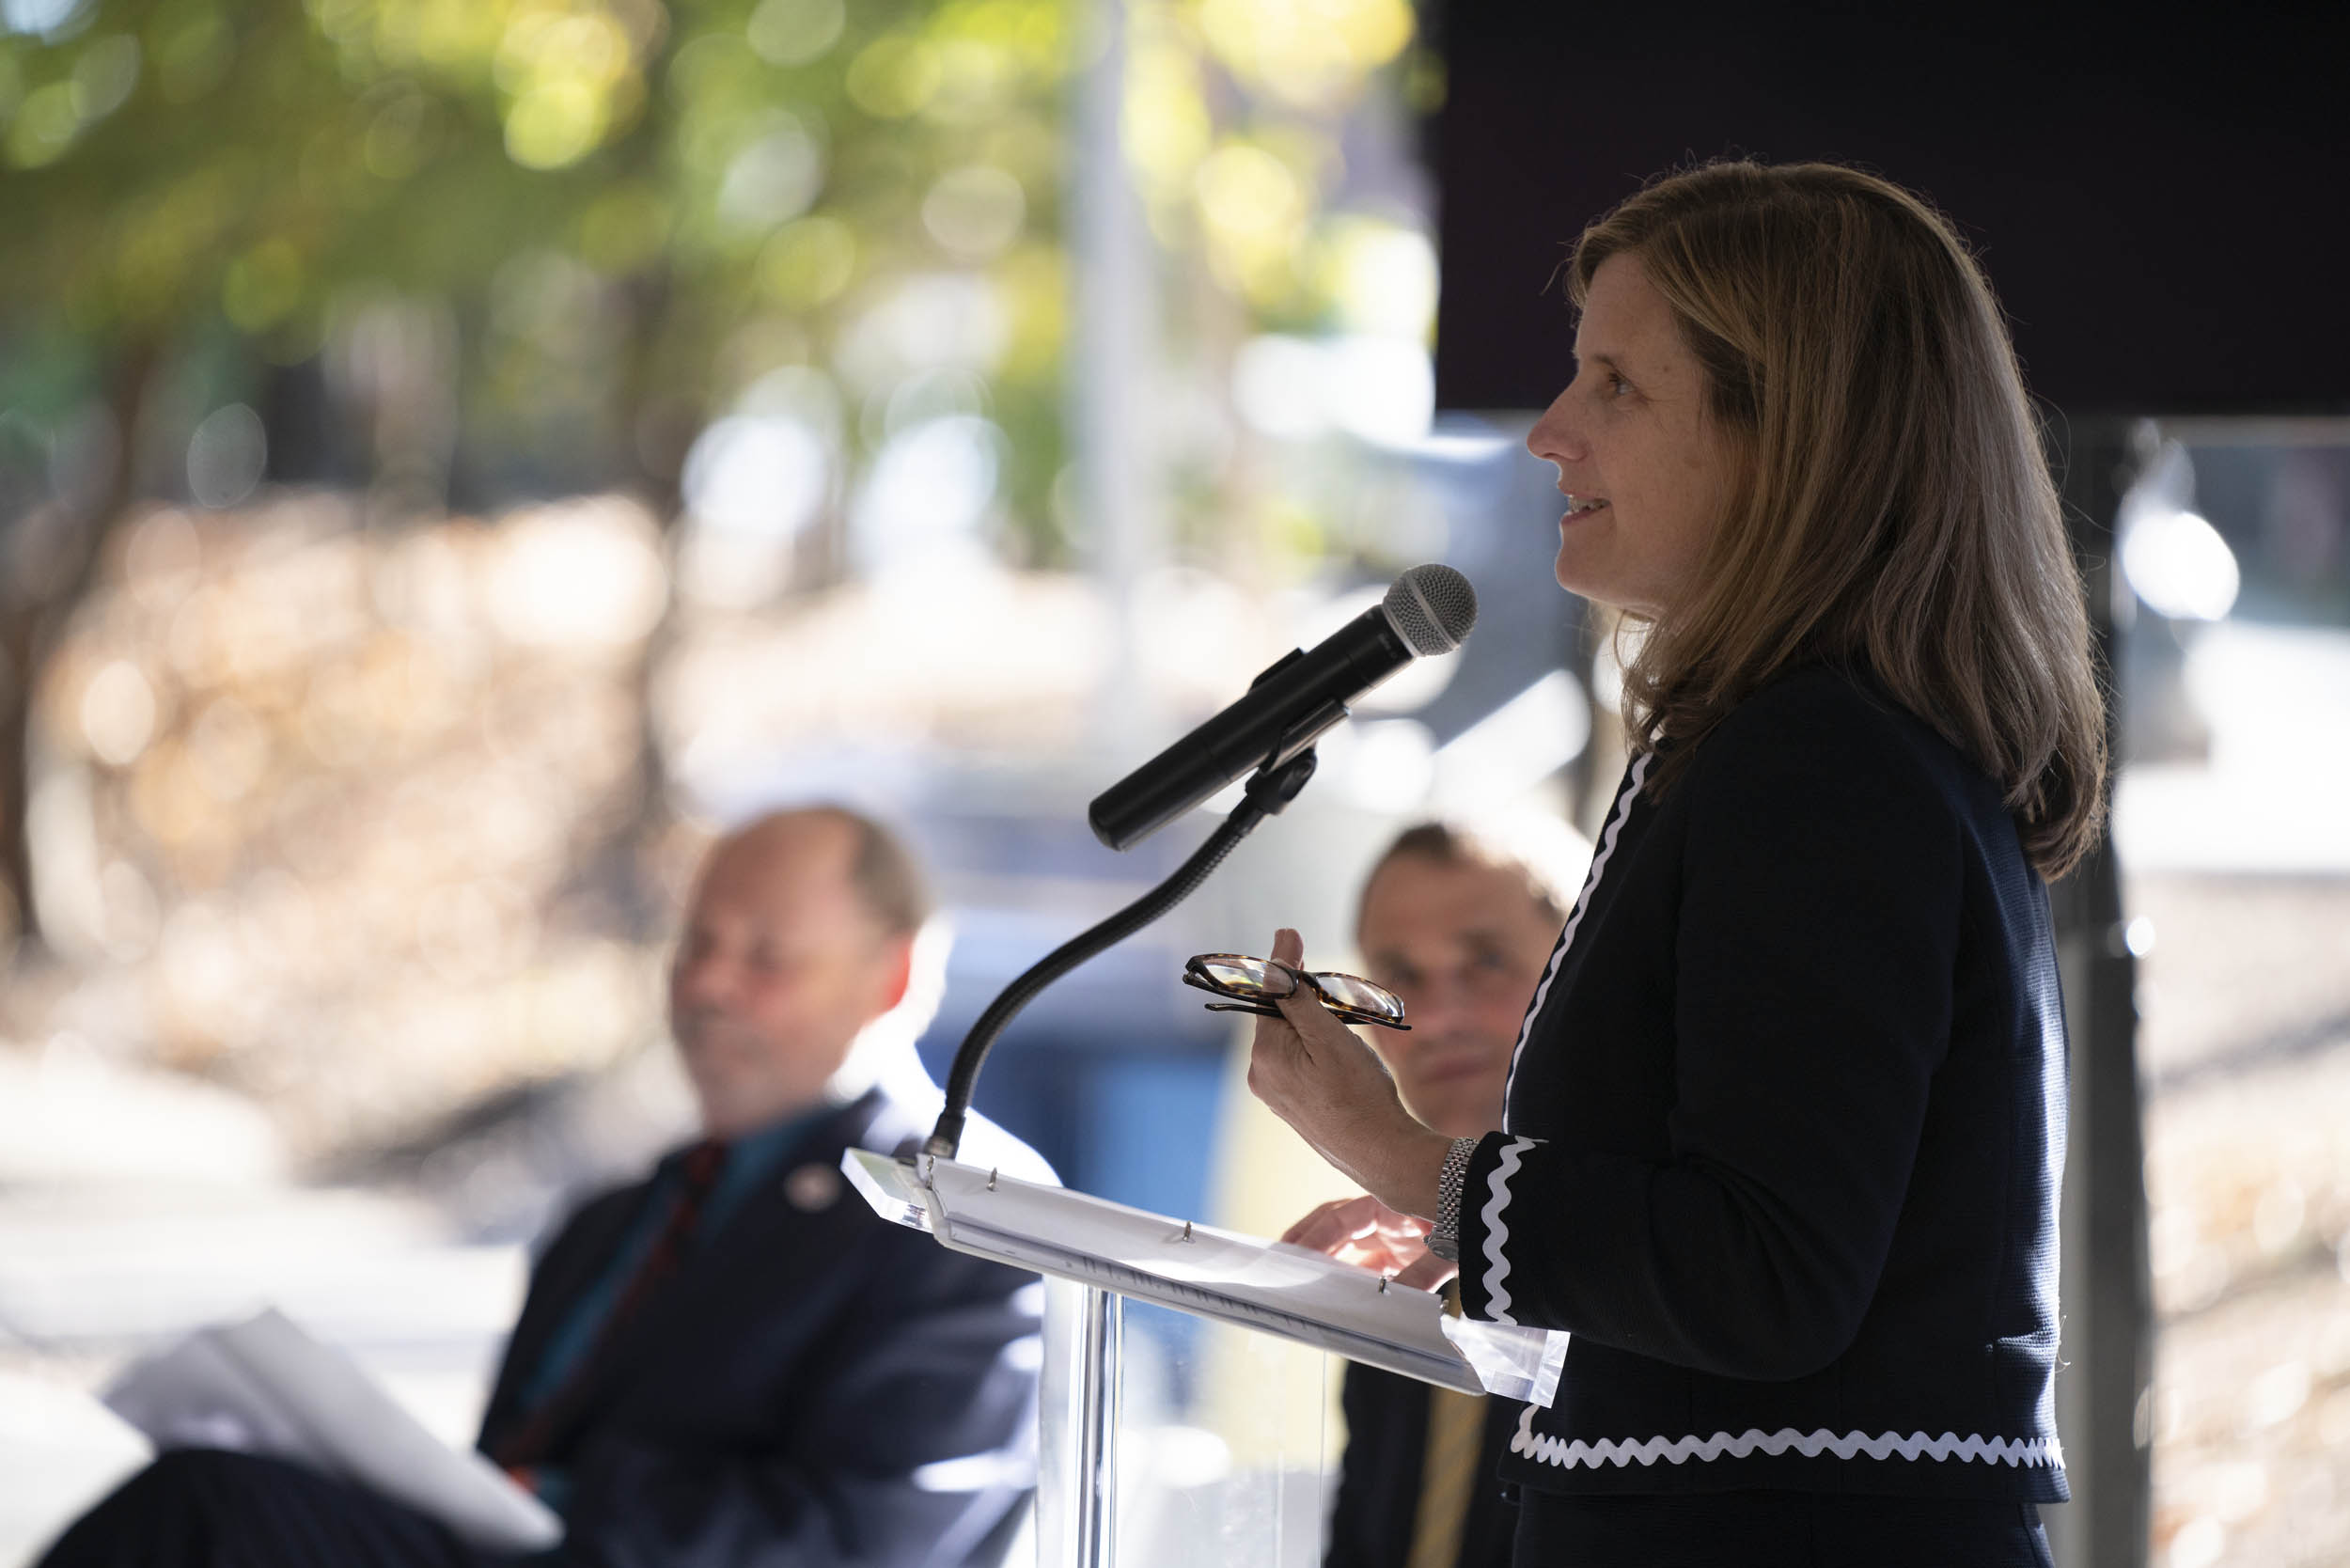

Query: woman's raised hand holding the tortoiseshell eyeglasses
1248,926,1452,1220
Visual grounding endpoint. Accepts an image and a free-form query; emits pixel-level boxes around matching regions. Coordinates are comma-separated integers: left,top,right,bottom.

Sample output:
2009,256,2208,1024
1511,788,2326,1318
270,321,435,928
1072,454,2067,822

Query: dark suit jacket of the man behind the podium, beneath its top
1324,1361,1526,1568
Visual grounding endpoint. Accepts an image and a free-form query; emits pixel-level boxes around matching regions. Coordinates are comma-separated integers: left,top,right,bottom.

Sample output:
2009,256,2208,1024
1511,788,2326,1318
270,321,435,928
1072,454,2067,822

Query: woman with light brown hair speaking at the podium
1250,163,2106,1568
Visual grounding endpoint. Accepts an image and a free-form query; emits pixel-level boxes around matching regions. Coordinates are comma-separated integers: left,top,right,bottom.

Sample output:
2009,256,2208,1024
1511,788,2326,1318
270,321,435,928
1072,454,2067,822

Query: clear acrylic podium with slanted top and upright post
841,1150,1568,1568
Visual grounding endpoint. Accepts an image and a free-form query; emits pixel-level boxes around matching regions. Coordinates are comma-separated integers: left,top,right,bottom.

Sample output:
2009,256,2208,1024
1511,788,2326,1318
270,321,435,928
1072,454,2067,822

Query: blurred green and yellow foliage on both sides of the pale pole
0,0,1443,569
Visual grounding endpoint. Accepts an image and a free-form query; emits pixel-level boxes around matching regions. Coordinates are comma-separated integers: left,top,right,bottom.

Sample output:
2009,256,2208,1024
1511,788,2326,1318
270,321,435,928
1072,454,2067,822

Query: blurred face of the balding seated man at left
670,816,912,1137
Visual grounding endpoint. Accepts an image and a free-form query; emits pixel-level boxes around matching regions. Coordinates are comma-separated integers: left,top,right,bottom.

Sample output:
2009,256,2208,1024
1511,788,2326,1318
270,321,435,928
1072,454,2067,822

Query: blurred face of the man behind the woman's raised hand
1356,855,1559,1137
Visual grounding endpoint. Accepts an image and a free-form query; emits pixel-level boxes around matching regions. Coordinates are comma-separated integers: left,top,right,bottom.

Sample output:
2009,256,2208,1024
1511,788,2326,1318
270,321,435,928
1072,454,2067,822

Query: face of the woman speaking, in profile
1526,254,1737,619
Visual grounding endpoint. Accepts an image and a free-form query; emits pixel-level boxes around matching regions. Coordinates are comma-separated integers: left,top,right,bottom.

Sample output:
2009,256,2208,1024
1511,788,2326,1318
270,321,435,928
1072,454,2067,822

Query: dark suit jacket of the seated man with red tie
479,1090,1043,1568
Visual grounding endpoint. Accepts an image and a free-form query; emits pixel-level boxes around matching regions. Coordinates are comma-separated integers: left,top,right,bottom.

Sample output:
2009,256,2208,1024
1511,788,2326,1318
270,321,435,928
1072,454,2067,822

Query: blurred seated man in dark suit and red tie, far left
34,808,1048,1568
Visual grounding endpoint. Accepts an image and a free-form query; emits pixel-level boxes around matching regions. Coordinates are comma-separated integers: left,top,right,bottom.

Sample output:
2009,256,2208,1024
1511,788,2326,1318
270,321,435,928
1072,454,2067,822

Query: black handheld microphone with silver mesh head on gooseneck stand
1086,567,1476,849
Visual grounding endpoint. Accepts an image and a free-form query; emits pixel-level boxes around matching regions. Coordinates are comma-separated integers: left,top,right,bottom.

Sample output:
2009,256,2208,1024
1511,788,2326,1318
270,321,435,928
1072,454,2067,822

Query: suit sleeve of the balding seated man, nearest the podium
564,1231,1042,1568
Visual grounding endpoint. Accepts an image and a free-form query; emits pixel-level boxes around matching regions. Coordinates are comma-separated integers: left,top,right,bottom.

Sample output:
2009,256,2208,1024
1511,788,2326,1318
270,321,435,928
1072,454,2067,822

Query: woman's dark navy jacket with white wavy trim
1460,667,2066,1502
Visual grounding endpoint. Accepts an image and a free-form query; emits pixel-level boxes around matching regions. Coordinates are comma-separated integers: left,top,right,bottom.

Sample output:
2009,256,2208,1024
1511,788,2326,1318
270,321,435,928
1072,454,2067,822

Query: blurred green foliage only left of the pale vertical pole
0,0,1074,545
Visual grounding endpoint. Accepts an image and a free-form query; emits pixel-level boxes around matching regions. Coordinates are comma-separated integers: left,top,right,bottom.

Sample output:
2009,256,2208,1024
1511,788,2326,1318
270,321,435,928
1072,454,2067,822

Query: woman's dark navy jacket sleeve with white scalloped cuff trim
1462,694,1965,1377
